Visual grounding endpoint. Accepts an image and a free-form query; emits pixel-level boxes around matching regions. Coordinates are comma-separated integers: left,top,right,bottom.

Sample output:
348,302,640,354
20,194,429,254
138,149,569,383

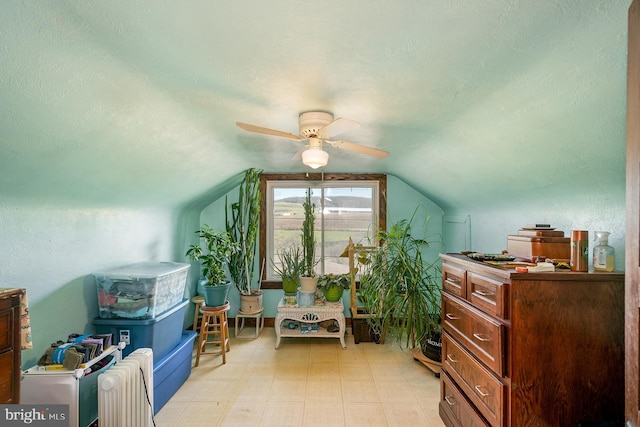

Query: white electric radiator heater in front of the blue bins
98,348,153,427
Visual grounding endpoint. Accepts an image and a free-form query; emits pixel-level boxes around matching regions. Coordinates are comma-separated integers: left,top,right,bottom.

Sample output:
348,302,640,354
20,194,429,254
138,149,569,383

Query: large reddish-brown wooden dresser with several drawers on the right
440,255,624,427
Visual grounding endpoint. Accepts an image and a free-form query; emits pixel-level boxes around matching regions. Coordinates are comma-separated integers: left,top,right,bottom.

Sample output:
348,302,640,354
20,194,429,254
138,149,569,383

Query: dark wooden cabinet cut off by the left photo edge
0,289,24,404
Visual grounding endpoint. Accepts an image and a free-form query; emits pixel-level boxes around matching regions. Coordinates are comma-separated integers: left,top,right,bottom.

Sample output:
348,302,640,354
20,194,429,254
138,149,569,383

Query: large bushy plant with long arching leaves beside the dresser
360,213,442,360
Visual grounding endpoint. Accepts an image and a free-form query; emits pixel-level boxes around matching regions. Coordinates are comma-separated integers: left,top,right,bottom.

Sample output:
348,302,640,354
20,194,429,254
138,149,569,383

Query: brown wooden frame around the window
258,173,387,289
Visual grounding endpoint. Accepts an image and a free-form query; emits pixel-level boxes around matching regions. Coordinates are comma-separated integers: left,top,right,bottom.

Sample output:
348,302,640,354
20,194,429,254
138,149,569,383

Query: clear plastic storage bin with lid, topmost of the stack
93,262,190,319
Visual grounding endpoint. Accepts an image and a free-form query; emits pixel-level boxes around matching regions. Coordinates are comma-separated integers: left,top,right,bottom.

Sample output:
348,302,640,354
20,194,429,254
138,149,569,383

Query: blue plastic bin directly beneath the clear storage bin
93,299,189,364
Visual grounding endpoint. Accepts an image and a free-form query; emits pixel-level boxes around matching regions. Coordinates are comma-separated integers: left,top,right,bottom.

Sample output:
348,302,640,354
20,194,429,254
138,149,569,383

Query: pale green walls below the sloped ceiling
0,169,625,368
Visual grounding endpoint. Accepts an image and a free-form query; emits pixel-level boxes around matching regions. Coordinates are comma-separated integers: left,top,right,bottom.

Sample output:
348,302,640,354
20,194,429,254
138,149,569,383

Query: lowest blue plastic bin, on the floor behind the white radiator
153,331,198,414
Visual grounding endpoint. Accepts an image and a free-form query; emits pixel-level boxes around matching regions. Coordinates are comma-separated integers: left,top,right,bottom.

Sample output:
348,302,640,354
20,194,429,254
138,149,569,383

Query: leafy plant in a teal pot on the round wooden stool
185,224,239,307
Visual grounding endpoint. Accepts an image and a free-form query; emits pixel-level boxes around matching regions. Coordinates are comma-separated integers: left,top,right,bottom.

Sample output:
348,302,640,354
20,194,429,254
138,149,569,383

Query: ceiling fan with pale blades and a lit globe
236,111,389,169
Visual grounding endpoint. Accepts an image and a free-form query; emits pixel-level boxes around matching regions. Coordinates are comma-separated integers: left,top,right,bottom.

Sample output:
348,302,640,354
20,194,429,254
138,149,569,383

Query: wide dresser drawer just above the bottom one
442,333,507,427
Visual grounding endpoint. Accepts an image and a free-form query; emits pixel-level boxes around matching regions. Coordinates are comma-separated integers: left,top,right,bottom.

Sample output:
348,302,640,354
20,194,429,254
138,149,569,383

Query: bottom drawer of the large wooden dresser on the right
439,371,489,427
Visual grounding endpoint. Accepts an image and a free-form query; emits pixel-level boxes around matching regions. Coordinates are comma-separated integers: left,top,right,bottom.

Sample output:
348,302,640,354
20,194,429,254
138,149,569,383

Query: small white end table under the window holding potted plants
274,298,347,349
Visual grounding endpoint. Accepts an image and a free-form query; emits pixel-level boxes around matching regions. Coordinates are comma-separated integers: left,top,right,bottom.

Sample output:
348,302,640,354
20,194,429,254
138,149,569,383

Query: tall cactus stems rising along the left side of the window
225,168,262,295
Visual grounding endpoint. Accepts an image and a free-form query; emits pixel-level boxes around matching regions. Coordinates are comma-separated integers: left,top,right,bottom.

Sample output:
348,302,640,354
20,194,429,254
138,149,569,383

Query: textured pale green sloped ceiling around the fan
0,0,630,210
